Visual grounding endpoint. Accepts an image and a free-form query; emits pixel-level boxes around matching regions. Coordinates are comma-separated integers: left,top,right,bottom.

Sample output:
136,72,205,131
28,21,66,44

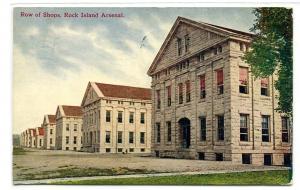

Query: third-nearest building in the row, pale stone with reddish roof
55,105,82,151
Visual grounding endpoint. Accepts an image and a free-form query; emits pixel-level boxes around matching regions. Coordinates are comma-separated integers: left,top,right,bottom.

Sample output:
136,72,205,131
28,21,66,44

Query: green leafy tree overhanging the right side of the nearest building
243,7,293,116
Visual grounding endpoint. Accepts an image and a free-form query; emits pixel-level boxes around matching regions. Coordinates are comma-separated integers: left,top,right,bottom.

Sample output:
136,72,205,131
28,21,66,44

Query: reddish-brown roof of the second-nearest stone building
96,83,151,100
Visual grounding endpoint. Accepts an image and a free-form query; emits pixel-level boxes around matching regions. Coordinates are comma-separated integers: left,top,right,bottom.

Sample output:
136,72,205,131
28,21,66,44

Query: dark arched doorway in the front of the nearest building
178,117,191,148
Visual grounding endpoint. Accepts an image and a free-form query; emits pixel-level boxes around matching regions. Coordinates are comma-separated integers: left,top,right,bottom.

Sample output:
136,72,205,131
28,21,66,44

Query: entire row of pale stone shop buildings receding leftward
19,17,292,165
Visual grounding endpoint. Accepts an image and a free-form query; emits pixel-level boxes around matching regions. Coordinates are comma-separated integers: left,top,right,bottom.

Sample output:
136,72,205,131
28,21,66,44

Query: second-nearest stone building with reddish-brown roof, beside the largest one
81,82,151,153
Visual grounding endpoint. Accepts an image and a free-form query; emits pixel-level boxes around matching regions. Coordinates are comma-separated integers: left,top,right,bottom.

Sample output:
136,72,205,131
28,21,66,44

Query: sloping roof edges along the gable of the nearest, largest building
147,17,254,75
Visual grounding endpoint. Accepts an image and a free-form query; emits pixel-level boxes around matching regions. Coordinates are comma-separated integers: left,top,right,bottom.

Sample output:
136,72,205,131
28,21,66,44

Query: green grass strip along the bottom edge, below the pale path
55,170,292,185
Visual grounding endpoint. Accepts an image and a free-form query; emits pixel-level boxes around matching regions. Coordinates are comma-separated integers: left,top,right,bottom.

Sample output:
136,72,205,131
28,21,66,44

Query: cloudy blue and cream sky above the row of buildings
13,7,255,133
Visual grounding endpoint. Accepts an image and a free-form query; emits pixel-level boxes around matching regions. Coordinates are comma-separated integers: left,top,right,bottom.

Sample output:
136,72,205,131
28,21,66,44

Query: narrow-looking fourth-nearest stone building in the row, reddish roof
42,115,56,150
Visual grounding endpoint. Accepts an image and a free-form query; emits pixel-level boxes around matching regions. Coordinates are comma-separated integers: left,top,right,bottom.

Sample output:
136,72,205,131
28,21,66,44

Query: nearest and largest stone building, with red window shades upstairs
148,17,292,165
